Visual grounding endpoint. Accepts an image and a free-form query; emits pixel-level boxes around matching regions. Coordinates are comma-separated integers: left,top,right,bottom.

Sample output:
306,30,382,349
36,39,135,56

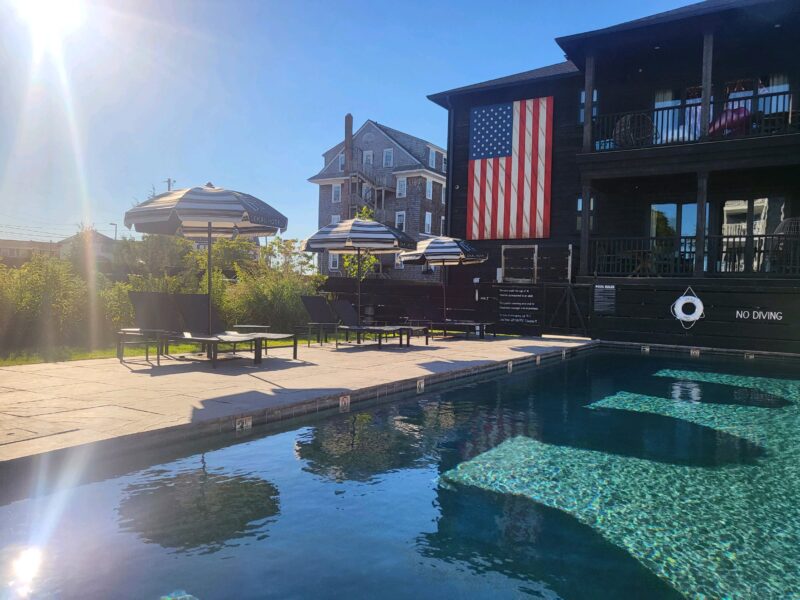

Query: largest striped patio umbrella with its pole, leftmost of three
125,183,289,333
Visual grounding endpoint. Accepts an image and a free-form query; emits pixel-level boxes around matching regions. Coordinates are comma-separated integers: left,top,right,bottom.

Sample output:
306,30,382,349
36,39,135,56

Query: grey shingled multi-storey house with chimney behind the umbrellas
309,114,447,280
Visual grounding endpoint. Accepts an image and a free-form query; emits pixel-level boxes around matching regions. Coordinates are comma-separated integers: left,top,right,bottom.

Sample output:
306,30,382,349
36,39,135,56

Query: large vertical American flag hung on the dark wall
467,96,553,240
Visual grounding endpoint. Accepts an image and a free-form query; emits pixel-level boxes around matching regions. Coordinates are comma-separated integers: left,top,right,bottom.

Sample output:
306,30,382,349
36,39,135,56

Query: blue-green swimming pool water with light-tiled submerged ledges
0,352,800,600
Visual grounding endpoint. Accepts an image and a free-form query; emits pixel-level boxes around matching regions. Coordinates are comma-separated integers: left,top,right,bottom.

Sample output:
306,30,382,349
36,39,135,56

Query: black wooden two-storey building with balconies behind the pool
430,0,800,352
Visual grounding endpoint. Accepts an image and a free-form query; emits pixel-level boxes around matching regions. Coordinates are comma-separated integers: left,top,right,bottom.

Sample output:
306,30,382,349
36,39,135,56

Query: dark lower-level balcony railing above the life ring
589,234,800,277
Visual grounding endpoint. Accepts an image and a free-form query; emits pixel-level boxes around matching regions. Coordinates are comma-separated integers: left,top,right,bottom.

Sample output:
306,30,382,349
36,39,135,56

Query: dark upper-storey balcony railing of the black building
592,92,800,152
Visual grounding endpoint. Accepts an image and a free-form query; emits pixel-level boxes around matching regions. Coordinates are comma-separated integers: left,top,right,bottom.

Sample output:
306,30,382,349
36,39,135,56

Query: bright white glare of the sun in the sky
16,0,85,55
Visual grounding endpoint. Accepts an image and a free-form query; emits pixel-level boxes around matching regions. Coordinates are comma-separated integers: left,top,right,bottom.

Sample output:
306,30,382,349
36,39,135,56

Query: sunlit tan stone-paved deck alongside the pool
0,336,594,463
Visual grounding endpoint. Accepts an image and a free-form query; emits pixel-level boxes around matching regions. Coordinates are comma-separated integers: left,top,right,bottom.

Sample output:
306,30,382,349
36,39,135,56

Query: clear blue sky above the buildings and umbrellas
0,0,691,241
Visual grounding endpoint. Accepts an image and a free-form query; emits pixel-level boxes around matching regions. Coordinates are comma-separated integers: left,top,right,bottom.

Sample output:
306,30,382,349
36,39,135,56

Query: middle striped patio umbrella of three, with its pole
300,219,417,323
